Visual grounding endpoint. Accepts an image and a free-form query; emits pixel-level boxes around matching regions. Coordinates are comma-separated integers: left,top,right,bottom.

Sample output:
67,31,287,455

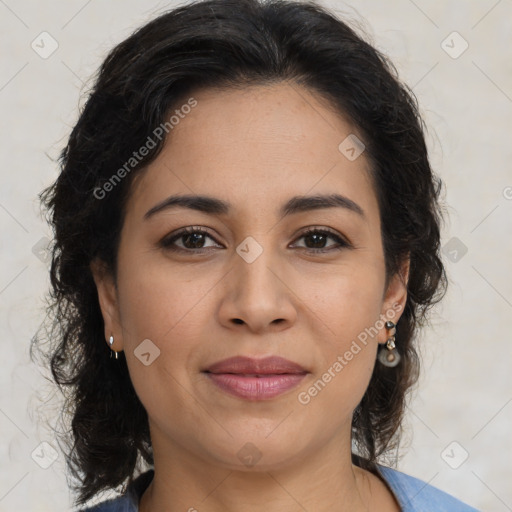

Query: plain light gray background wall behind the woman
0,0,512,512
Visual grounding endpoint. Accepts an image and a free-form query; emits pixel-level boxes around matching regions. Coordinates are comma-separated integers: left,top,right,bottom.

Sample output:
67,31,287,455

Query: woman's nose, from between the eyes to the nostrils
219,242,297,333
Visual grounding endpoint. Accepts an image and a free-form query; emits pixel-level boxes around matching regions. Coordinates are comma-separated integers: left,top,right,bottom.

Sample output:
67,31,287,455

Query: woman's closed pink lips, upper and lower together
204,356,309,400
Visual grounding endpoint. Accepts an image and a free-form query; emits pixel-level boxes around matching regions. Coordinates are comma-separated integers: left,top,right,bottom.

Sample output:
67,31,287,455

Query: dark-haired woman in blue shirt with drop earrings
36,0,480,512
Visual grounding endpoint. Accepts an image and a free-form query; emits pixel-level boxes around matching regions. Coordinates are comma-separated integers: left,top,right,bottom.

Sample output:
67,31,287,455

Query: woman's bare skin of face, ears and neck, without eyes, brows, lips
92,83,408,512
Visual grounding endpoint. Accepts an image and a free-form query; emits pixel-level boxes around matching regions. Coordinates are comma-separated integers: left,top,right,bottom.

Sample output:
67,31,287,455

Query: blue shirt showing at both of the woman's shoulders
79,465,479,512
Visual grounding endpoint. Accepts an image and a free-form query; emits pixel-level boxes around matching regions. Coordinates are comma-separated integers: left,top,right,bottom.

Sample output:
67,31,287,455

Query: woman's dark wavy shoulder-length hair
31,0,447,504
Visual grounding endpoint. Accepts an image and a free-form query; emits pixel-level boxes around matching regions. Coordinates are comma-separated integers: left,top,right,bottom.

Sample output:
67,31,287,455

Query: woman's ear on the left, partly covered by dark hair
90,259,123,352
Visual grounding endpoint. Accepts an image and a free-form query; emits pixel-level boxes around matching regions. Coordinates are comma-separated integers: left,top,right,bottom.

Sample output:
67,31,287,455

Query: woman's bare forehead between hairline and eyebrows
126,83,376,221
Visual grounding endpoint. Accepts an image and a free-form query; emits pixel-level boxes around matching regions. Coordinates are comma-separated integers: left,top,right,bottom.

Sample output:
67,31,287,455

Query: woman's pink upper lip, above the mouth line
204,356,308,376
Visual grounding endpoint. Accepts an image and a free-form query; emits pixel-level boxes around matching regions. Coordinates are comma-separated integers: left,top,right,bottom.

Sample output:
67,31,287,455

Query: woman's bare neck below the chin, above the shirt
139,424,375,512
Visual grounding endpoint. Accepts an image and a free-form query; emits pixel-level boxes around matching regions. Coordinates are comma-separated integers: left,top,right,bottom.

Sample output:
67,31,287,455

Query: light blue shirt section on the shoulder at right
377,465,478,512
